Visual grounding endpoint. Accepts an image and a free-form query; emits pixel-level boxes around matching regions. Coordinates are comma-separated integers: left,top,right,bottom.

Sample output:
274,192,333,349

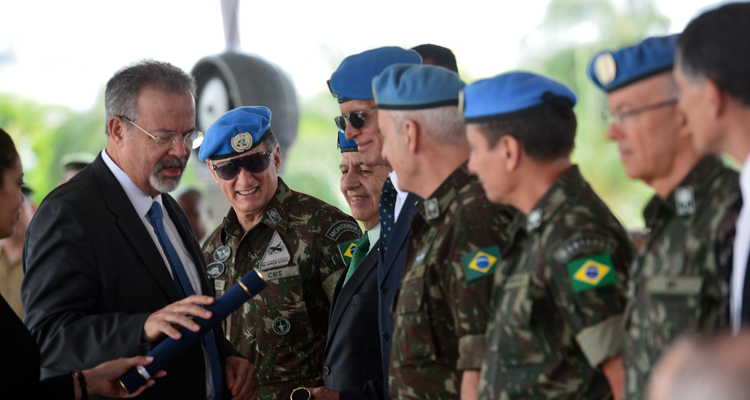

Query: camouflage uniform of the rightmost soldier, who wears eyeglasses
624,157,739,399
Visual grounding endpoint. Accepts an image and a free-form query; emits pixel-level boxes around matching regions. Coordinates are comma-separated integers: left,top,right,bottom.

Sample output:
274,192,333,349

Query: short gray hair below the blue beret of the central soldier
392,106,468,146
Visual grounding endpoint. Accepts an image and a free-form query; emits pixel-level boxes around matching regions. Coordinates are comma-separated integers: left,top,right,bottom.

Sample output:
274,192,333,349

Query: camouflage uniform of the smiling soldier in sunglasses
203,178,361,400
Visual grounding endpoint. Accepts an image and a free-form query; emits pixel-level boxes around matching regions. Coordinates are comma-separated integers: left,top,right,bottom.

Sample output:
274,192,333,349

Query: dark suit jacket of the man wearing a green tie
323,240,383,400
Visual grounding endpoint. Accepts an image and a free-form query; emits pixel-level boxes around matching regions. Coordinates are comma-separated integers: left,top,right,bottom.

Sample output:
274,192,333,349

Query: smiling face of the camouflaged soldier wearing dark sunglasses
206,144,281,223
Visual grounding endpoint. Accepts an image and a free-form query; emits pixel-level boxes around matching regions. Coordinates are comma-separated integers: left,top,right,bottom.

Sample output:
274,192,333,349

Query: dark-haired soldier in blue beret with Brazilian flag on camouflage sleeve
462,72,634,399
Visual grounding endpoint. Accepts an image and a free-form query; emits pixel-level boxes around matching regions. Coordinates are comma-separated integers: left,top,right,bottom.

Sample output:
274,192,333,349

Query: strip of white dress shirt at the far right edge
729,156,750,335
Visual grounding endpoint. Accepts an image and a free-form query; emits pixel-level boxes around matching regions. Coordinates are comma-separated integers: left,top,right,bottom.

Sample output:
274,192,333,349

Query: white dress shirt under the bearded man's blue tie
102,149,214,400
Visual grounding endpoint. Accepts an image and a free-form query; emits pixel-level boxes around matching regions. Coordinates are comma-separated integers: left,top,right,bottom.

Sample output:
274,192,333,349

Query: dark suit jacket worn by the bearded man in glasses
21,155,237,400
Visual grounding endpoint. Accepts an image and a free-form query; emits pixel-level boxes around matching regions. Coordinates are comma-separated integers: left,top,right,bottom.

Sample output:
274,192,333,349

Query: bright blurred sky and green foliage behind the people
0,0,722,229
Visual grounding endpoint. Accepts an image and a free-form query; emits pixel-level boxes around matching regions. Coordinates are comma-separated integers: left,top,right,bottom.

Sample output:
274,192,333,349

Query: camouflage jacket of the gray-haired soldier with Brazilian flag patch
389,164,514,399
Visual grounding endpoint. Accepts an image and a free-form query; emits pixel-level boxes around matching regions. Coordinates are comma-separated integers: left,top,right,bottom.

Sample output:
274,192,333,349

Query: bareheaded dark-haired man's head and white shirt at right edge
674,2,750,334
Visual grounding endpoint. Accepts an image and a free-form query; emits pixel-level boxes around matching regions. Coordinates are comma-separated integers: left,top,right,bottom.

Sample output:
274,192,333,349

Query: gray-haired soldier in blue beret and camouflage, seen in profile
373,64,515,399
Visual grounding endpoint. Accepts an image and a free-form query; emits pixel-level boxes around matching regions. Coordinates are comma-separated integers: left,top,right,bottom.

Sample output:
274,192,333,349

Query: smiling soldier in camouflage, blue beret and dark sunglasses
199,107,360,400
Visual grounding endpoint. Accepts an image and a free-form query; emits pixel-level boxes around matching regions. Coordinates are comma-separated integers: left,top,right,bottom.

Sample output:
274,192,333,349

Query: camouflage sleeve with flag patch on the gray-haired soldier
446,217,505,370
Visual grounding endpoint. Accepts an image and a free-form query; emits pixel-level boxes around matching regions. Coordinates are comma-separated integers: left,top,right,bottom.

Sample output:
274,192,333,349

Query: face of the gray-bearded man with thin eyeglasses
110,86,195,196
